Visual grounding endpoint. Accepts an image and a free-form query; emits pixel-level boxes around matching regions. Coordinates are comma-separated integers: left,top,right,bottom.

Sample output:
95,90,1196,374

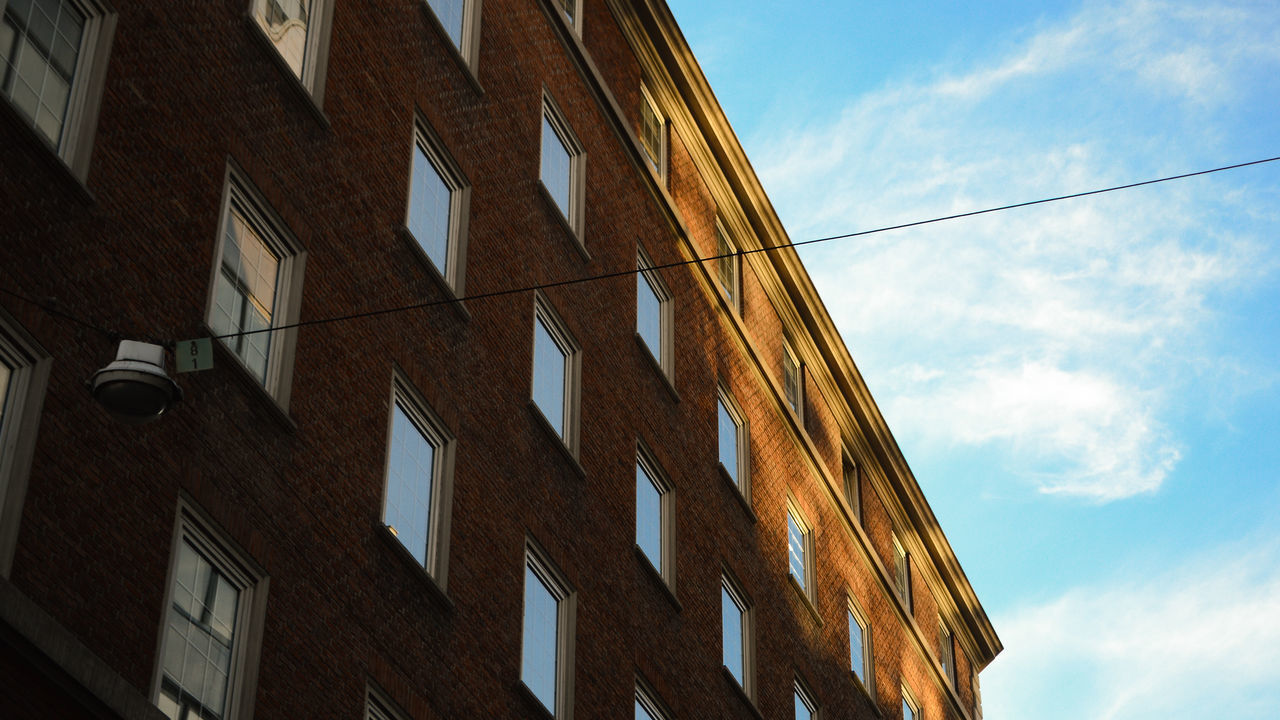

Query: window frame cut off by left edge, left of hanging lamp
0,309,54,578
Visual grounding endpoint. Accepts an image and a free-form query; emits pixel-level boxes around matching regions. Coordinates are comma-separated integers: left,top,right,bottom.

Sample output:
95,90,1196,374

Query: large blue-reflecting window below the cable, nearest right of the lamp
383,374,456,588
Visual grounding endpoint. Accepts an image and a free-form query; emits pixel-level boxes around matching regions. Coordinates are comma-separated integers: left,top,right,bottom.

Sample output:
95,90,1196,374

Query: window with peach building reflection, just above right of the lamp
206,165,305,407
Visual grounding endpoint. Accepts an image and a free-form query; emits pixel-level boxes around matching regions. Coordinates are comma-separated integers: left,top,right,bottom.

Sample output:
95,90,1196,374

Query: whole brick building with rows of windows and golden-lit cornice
0,0,1001,720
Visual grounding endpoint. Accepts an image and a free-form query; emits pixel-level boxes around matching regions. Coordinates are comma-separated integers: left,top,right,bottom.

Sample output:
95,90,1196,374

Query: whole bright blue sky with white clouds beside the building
669,0,1280,720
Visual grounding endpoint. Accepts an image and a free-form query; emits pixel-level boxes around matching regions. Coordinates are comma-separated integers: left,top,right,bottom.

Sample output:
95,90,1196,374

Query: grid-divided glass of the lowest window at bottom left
159,539,239,719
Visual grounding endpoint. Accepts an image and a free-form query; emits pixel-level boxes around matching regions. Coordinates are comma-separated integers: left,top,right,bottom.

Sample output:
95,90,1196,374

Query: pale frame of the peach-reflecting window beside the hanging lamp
205,164,307,411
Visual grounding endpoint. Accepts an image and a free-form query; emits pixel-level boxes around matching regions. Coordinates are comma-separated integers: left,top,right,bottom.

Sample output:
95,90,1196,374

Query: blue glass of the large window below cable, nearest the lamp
383,402,435,568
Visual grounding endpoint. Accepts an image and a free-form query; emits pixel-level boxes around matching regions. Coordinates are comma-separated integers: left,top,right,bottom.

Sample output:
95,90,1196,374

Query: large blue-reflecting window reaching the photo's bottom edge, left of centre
520,544,573,717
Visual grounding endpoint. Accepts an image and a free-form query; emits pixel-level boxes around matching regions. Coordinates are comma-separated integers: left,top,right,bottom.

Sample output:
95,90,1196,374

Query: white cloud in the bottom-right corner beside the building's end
982,541,1280,720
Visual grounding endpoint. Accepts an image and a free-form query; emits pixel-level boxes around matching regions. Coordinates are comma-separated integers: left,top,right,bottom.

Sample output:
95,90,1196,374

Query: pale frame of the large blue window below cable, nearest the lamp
381,370,457,591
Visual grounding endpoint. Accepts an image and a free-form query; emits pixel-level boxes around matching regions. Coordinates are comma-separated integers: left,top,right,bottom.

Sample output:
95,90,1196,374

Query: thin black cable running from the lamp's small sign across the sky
214,151,1280,340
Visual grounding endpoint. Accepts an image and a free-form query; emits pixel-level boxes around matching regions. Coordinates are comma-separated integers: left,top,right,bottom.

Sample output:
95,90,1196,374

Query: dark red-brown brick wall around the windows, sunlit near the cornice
0,0,998,720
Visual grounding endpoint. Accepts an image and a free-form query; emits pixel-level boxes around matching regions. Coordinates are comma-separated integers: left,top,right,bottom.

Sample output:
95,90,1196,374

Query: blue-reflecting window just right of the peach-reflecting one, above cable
404,122,471,295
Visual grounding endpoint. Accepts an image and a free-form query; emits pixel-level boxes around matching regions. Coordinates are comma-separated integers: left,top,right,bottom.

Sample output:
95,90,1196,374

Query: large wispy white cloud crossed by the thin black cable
748,0,1280,502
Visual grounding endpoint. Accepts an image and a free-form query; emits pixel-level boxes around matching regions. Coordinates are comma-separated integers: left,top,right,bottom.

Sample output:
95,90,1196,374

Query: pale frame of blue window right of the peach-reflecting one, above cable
404,115,471,296
